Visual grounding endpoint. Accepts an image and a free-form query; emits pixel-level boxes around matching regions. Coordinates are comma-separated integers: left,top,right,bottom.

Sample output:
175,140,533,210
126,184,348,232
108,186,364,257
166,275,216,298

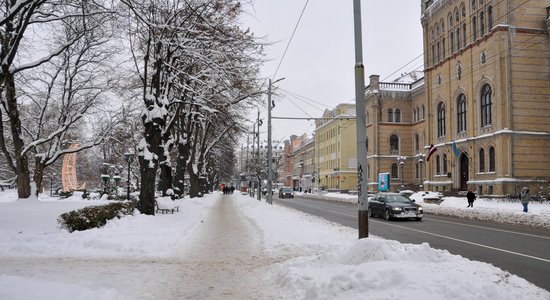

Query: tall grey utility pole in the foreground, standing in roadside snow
353,0,369,239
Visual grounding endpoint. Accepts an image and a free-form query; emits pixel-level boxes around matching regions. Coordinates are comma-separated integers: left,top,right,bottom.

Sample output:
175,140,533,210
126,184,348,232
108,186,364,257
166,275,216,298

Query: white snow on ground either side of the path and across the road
0,191,550,300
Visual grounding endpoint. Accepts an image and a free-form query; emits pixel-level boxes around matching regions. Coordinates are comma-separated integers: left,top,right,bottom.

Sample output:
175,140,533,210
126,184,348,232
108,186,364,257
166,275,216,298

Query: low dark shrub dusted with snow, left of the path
57,202,134,232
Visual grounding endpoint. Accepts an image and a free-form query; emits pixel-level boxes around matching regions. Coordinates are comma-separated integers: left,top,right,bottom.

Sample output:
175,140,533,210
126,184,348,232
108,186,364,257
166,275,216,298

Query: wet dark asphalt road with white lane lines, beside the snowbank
273,194,550,291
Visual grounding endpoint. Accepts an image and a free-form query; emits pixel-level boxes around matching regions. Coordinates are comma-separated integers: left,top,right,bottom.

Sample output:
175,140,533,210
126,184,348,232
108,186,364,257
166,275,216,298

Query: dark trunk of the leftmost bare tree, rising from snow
3,70,31,199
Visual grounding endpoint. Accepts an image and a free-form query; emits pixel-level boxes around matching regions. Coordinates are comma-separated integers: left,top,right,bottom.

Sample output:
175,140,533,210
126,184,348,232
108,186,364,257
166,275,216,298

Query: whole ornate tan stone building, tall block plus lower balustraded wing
366,0,550,195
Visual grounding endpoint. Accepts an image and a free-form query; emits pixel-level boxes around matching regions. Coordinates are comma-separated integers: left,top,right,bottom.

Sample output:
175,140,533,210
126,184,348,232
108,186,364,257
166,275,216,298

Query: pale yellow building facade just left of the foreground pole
315,104,357,191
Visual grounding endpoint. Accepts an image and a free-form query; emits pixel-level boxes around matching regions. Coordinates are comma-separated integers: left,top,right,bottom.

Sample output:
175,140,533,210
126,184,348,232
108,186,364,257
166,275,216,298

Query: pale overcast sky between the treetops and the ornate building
243,0,423,140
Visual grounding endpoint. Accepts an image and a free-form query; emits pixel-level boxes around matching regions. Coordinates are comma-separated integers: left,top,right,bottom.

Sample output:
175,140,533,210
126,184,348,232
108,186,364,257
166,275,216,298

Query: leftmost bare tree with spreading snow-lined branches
0,0,116,198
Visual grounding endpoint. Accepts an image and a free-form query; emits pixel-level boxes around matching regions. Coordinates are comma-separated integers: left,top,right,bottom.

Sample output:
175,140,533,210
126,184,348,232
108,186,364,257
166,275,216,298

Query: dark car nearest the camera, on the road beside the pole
369,193,423,221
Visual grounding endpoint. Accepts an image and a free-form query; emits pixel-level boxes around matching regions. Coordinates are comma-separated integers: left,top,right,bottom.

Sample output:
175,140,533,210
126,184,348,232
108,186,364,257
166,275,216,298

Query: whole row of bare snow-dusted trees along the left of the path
0,0,263,214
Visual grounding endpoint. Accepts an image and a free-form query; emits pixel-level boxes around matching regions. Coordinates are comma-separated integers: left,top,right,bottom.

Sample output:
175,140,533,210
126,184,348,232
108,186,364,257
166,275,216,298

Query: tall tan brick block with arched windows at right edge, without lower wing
422,0,550,194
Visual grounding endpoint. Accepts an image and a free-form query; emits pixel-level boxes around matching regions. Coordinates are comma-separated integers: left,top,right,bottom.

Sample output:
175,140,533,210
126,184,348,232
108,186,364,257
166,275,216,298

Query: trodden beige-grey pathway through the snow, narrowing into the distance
175,195,280,299
